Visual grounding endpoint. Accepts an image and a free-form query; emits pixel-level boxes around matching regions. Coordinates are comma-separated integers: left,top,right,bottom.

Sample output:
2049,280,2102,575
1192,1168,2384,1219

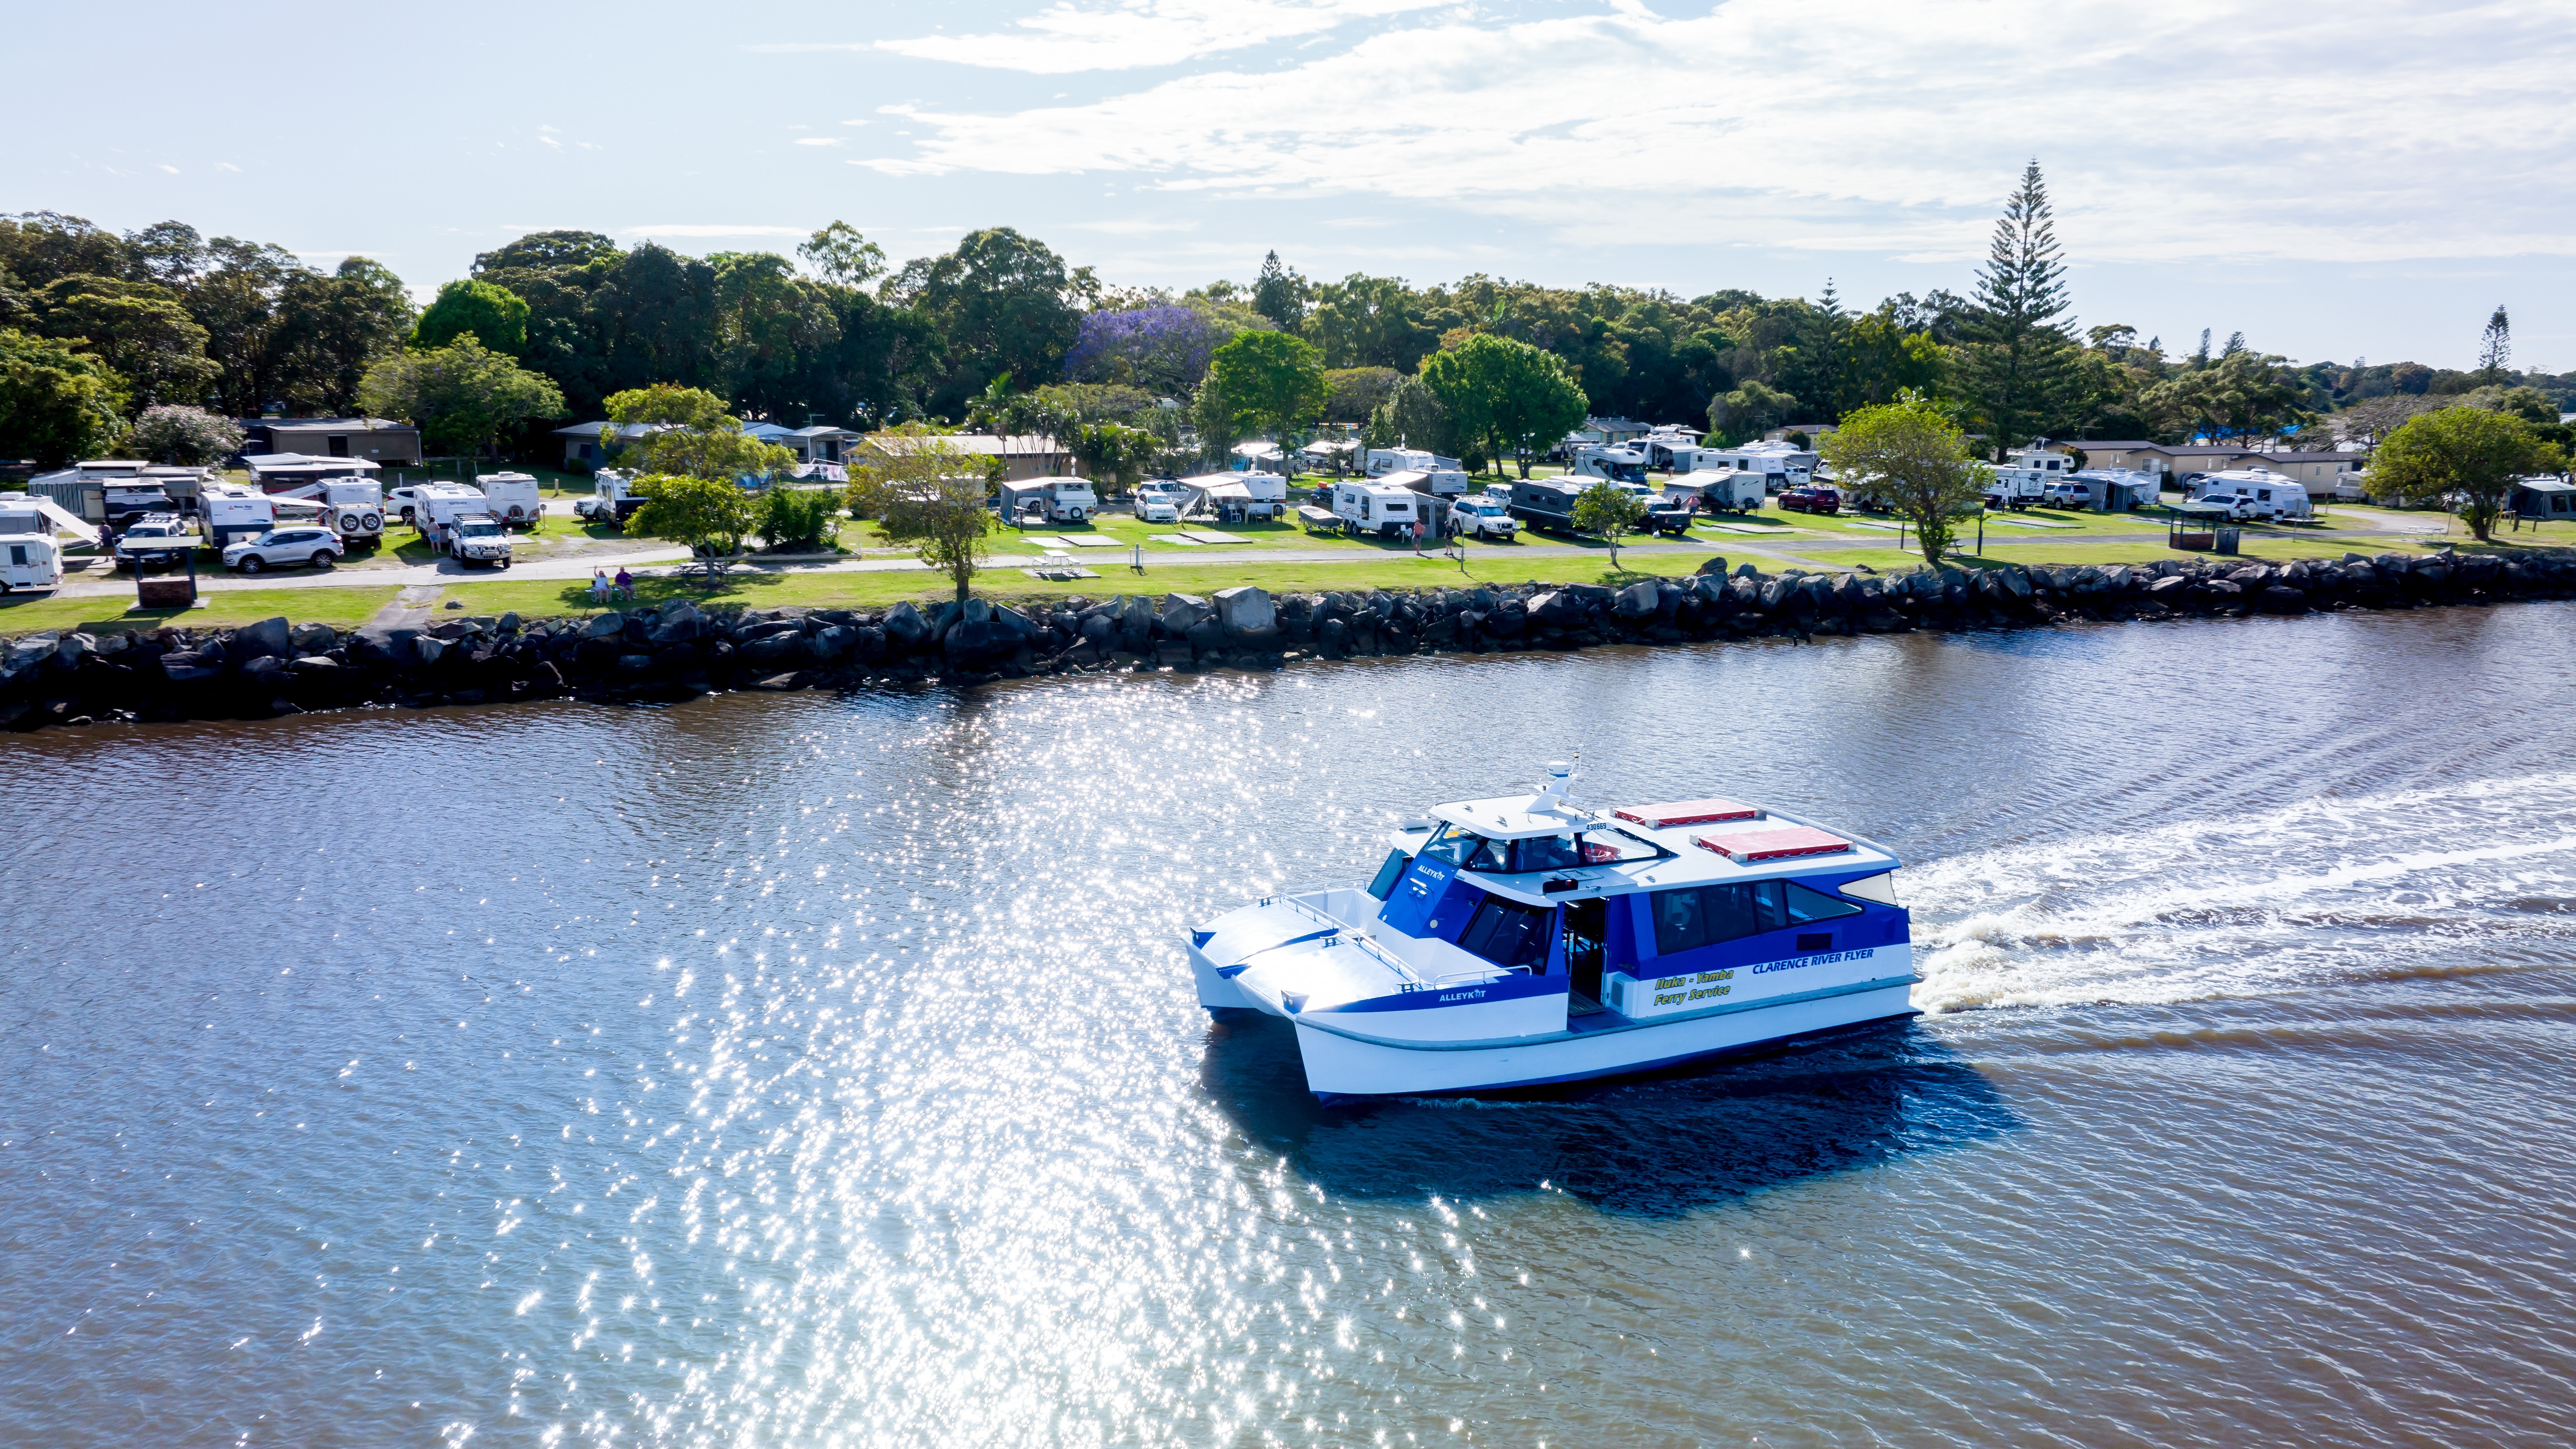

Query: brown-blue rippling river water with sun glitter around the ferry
0,606,2576,1449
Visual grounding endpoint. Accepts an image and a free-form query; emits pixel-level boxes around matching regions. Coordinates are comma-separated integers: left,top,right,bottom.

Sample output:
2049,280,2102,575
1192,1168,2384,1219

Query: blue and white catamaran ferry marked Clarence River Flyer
1190,763,1922,1096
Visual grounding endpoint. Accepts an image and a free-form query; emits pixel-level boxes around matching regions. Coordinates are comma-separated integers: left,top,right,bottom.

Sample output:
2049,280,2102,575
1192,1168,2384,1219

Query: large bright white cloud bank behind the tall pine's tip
861,0,2576,261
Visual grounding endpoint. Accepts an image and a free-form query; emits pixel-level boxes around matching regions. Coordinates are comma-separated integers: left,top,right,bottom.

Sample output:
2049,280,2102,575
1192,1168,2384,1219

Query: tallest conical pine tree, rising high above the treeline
1960,160,2073,449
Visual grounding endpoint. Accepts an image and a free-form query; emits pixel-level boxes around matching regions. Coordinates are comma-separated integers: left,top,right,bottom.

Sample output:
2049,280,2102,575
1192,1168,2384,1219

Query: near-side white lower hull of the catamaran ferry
1296,972,1916,1096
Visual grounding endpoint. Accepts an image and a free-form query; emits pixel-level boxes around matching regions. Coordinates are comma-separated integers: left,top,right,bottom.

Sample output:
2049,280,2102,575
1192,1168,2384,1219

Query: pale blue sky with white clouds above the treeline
0,0,2576,371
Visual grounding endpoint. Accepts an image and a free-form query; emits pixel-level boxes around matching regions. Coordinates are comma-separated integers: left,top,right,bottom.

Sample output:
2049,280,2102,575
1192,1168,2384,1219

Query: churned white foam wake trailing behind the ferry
1901,773,2576,1013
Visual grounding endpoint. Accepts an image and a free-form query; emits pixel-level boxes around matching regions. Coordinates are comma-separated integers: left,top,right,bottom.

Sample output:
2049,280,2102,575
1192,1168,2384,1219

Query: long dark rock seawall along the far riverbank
0,552,2576,730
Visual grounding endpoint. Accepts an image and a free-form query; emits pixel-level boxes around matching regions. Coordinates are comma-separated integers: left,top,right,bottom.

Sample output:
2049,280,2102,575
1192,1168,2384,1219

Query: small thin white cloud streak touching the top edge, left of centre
749,0,1453,75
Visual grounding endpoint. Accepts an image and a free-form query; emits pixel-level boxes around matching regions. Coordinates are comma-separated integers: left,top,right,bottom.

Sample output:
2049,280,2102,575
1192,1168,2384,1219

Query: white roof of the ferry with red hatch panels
1429,794,1904,905
